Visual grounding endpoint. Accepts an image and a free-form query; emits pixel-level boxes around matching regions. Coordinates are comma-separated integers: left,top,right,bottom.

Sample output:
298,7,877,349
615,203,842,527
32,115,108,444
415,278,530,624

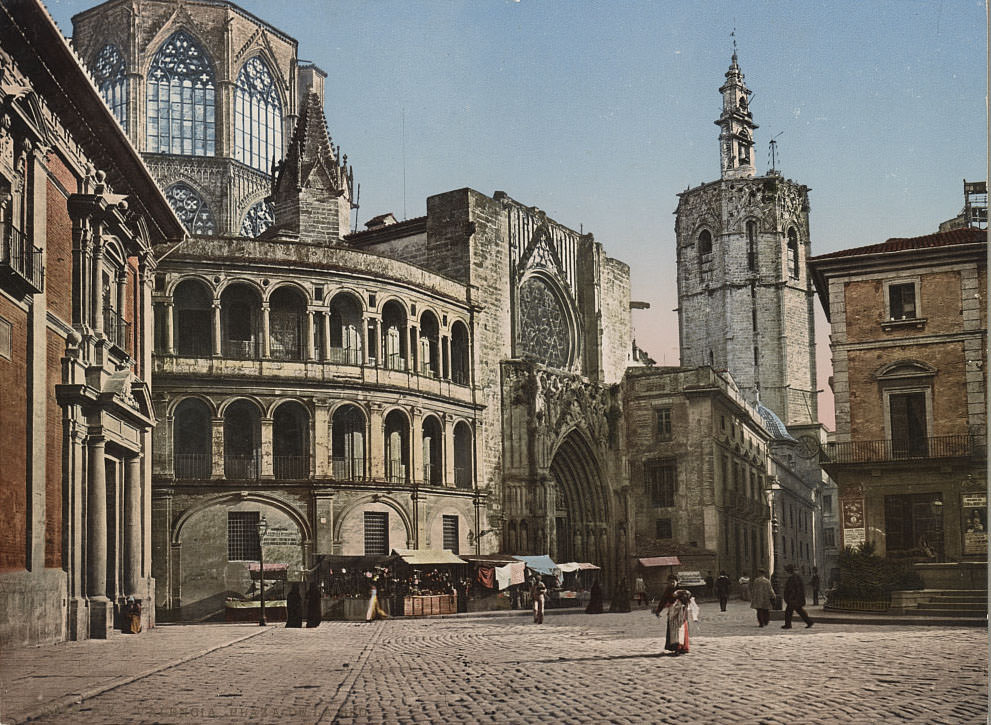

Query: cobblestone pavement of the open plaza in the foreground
3,604,987,725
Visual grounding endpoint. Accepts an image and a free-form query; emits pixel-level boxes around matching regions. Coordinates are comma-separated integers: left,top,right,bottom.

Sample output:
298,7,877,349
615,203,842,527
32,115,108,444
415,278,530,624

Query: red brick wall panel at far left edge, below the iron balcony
0,296,27,571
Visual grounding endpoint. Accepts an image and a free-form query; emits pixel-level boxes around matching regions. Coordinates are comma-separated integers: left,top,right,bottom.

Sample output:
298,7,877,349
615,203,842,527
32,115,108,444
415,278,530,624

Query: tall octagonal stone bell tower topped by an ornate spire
675,52,818,426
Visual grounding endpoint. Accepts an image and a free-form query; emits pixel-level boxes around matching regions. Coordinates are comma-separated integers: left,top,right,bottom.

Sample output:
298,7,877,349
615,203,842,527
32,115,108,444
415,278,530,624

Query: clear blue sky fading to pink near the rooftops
47,0,988,428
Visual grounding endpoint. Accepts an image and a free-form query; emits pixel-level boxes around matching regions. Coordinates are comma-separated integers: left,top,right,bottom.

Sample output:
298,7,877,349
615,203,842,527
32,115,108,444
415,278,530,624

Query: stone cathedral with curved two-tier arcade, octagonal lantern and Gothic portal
74,0,633,616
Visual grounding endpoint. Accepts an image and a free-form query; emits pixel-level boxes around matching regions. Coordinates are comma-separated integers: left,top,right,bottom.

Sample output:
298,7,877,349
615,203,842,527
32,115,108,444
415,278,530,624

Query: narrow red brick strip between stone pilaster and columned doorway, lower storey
45,330,65,568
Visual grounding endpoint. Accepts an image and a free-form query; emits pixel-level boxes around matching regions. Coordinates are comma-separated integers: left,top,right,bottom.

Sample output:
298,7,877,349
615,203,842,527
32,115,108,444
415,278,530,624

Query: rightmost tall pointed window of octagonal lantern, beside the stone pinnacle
234,56,282,174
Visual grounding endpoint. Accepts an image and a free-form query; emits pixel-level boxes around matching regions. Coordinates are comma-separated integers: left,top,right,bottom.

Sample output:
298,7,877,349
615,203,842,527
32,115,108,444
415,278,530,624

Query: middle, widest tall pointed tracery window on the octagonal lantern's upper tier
147,30,216,156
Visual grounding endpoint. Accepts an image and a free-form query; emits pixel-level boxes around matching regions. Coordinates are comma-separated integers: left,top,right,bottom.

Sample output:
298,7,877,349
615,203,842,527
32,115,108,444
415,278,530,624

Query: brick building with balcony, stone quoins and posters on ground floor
810,227,987,588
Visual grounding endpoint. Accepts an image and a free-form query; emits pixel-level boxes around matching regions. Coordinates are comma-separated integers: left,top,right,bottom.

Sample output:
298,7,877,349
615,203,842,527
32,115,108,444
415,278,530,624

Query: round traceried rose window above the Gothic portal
517,277,571,368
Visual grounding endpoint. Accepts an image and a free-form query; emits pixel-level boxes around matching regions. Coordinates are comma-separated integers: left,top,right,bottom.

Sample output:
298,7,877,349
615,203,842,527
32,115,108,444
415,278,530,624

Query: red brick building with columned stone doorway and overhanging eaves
0,0,183,647
